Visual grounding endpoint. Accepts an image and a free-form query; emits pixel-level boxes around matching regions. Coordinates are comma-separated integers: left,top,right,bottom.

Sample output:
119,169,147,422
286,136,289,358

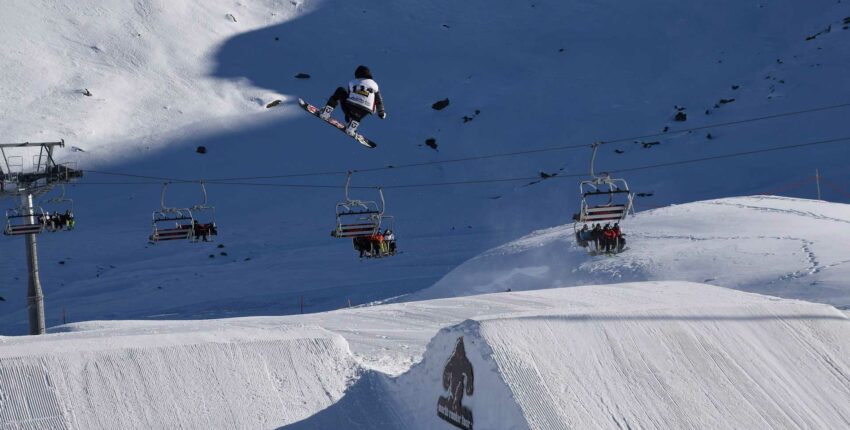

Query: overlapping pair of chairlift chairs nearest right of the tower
148,181,218,243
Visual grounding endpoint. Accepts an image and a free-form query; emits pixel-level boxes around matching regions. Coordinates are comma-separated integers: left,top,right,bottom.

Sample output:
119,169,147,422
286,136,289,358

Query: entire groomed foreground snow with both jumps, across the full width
0,282,850,429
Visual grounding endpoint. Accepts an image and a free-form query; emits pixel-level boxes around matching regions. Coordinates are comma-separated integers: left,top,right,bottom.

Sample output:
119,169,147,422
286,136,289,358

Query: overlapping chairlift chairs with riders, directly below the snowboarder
331,171,396,258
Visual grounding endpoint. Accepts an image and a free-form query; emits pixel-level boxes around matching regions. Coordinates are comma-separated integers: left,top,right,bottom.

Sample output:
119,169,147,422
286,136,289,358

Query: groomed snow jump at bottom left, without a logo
0,327,356,429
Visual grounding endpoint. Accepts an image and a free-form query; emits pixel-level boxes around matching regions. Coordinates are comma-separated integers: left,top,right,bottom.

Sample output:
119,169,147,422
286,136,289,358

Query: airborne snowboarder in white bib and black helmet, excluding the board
319,65,387,136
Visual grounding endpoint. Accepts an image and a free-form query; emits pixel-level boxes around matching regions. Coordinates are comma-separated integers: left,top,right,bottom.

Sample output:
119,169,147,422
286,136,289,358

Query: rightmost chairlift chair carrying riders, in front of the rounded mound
573,142,634,255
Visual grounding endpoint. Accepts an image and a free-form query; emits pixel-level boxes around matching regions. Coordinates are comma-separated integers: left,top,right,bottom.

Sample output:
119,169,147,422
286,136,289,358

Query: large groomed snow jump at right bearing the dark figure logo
284,282,850,429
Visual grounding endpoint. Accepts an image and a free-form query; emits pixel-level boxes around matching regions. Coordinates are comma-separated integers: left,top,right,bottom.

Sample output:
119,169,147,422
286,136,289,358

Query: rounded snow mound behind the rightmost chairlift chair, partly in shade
411,196,850,308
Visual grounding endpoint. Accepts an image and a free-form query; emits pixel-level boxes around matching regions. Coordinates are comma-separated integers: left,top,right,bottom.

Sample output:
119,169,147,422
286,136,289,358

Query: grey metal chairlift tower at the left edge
0,140,83,335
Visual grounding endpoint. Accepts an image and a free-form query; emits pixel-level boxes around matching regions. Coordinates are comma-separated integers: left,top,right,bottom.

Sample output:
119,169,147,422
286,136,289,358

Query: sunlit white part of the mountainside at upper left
0,0,304,152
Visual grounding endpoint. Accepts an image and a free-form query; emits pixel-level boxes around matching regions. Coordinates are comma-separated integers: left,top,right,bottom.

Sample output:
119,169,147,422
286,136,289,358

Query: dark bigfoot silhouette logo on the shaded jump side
437,336,474,430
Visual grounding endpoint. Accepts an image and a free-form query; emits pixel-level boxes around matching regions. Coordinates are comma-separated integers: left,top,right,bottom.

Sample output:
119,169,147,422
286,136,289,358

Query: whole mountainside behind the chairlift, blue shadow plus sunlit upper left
0,0,850,334
